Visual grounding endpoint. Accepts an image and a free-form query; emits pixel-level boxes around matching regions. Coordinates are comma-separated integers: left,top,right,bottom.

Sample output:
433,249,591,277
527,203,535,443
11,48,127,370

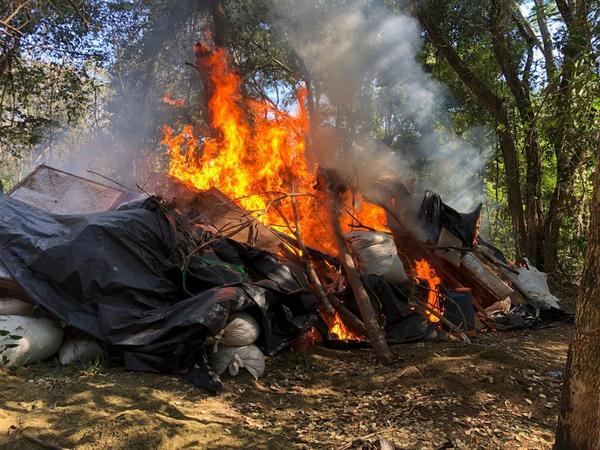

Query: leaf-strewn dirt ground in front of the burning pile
0,289,573,450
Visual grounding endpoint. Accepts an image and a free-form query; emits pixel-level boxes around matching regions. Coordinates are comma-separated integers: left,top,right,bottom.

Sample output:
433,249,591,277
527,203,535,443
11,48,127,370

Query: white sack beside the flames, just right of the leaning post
346,231,408,283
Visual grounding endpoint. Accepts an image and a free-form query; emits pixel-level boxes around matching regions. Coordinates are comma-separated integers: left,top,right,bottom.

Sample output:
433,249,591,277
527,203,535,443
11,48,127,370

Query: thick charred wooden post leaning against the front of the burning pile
320,170,392,364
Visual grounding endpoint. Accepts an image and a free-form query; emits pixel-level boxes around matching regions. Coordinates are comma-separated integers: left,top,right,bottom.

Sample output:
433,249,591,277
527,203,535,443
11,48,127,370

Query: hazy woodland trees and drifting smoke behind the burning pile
0,0,600,273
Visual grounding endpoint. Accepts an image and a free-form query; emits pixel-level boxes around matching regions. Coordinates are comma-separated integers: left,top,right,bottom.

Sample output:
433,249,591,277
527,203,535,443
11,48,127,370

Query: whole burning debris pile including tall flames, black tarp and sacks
0,44,566,392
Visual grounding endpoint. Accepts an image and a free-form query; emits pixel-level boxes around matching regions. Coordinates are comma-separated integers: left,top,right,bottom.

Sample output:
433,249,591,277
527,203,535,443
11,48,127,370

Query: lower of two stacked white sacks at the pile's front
209,345,265,379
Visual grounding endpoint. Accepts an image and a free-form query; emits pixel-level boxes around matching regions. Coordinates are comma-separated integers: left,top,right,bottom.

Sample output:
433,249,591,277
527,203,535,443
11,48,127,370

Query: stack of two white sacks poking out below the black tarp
209,313,265,379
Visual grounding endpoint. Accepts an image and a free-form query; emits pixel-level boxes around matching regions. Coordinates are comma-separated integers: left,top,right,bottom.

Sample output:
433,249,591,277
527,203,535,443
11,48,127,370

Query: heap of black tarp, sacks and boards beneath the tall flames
0,166,570,391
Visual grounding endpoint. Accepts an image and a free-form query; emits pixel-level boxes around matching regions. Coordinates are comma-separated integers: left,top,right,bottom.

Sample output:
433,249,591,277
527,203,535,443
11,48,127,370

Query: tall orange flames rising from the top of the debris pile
162,44,387,251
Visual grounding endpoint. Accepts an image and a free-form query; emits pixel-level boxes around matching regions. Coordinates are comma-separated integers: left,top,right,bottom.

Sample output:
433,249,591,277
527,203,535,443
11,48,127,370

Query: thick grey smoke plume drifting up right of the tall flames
273,0,489,210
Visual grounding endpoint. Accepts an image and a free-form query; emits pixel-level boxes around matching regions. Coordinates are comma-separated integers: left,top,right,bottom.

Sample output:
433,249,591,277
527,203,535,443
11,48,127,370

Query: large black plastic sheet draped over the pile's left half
0,195,317,384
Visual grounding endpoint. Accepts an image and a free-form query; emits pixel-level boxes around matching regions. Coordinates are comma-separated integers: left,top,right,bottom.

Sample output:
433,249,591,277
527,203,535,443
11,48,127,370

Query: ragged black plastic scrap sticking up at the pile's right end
419,191,482,247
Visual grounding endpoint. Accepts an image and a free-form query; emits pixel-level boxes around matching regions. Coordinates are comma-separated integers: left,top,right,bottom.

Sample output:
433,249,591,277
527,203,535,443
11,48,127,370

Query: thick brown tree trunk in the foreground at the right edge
554,147,600,450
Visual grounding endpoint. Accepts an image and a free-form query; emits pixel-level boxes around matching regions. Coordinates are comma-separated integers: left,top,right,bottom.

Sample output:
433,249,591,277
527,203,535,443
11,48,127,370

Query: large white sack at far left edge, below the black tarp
0,315,63,366
